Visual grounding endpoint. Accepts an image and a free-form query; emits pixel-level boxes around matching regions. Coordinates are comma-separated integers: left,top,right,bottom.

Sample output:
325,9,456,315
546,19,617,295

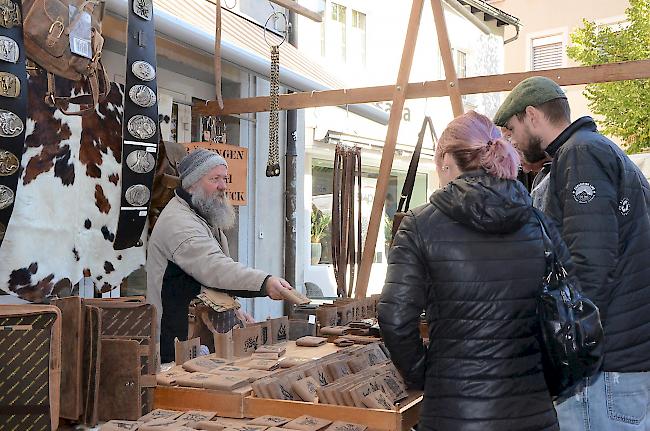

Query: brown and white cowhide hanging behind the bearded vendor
0,72,146,302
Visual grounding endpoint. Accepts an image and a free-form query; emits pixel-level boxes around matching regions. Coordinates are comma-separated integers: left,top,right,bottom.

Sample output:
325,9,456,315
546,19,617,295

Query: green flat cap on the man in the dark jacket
494,76,566,127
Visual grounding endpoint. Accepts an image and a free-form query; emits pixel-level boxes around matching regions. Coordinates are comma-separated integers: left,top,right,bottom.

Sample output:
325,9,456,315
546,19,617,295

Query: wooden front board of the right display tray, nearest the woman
244,392,422,431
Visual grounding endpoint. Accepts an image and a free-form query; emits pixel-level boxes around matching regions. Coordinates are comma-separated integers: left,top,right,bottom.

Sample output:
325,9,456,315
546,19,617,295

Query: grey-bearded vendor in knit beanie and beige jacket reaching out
146,149,292,363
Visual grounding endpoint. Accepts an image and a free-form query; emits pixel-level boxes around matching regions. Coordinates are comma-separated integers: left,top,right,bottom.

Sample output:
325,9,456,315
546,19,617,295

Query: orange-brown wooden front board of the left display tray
154,386,252,419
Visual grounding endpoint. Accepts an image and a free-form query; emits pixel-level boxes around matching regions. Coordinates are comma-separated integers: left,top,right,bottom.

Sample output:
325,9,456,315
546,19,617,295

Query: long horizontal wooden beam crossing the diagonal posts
192,60,650,115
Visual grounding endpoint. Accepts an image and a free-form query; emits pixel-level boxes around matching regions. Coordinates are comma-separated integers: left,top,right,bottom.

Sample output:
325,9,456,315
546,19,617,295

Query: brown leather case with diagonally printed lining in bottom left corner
0,305,61,430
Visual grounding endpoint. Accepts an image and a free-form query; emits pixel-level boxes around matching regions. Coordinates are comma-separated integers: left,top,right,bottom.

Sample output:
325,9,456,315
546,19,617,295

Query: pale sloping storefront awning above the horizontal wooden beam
106,0,388,124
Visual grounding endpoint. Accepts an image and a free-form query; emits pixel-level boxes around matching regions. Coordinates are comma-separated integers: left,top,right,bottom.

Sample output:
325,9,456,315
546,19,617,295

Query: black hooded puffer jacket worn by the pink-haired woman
378,171,568,431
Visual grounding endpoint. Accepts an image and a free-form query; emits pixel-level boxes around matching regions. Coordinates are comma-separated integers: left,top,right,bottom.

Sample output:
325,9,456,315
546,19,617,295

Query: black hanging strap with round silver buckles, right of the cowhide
113,0,160,250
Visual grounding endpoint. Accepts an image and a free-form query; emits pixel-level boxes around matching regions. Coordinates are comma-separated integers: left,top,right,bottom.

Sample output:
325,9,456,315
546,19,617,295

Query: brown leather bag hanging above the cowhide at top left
23,0,110,115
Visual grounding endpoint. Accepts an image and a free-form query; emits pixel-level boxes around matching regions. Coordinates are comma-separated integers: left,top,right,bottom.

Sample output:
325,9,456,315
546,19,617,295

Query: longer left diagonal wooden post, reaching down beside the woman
355,0,424,298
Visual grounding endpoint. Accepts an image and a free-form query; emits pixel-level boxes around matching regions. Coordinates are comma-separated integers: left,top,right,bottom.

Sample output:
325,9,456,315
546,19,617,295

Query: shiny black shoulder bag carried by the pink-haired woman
534,210,603,398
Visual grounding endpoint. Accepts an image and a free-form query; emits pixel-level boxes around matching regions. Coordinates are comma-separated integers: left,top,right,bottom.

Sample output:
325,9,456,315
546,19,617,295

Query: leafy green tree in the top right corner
567,0,650,153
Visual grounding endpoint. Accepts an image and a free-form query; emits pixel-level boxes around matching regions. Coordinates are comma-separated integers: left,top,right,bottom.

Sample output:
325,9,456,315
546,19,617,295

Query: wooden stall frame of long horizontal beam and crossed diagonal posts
193,0,650,298
